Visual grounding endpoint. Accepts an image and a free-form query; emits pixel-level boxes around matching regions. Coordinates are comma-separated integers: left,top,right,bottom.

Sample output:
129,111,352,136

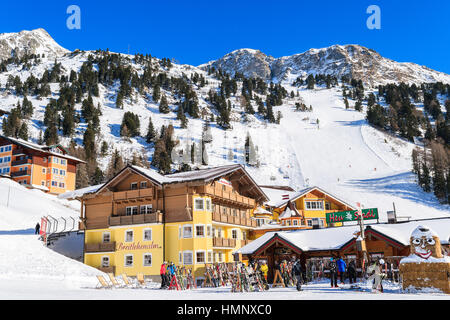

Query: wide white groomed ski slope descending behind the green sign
272,88,450,221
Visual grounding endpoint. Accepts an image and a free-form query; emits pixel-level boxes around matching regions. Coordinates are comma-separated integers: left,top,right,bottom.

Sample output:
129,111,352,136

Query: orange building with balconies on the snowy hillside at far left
0,135,84,194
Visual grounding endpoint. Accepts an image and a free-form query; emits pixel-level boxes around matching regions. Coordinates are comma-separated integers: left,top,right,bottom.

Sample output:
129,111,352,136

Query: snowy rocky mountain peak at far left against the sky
0,28,69,60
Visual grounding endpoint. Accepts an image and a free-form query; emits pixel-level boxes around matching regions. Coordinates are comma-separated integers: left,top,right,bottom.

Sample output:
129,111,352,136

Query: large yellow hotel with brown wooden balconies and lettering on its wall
75,165,268,281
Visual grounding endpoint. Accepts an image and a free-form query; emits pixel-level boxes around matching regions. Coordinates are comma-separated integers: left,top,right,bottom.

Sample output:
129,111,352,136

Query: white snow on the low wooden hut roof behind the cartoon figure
237,218,450,254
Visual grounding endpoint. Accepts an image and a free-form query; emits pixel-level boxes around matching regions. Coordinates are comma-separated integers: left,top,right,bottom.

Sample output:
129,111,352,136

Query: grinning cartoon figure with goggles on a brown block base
400,225,450,294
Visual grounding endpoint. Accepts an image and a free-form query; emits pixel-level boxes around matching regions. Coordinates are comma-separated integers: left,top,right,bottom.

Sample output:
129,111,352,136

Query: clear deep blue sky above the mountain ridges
0,0,450,73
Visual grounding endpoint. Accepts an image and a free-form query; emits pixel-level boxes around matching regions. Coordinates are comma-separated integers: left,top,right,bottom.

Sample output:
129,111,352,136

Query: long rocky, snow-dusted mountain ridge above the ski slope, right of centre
199,45,450,86
